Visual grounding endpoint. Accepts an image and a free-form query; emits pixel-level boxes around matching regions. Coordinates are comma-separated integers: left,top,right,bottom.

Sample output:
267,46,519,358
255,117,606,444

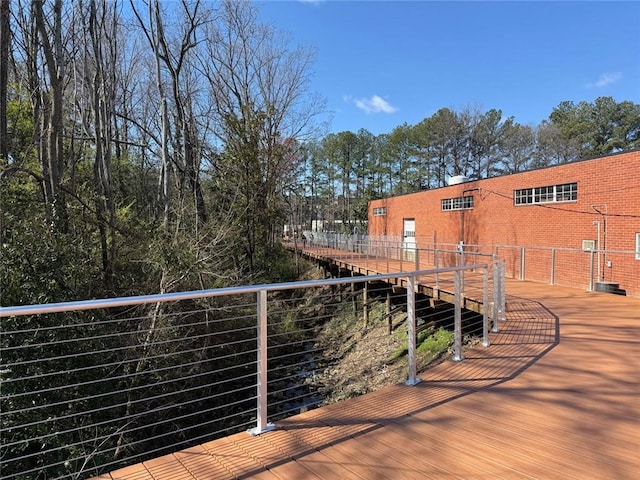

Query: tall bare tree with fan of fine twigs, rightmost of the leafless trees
201,0,322,270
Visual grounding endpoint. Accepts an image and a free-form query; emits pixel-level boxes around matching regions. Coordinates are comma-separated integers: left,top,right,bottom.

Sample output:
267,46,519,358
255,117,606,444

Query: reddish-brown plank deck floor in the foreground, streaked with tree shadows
99,251,640,480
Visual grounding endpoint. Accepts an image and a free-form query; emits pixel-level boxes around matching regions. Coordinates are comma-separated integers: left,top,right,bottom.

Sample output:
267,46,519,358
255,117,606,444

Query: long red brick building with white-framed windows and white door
369,151,640,296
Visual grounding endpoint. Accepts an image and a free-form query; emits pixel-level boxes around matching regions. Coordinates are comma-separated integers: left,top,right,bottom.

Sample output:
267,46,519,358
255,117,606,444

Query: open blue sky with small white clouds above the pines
256,0,640,135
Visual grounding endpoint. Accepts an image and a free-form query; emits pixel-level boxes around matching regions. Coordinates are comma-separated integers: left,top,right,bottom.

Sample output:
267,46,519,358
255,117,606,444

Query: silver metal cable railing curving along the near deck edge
0,263,504,480
